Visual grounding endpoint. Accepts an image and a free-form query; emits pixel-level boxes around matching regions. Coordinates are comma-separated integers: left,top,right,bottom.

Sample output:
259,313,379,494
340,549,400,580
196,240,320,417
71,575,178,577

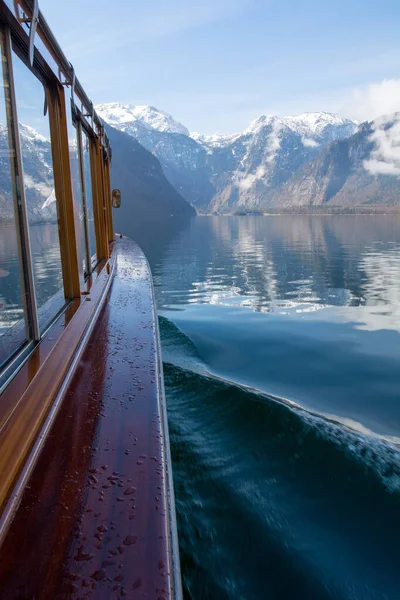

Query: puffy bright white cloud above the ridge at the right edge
341,79,400,121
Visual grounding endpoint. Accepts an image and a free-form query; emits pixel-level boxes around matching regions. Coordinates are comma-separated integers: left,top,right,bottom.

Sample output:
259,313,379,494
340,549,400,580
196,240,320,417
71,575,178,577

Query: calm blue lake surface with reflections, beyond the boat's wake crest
145,215,400,436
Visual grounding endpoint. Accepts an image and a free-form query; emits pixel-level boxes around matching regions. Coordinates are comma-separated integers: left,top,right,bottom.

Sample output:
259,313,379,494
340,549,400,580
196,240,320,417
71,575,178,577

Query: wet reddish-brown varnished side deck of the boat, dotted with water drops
0,239,176,600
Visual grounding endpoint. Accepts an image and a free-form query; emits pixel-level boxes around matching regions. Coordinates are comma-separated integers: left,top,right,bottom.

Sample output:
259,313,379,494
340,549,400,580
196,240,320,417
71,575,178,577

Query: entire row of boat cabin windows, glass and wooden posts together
0,24,110,385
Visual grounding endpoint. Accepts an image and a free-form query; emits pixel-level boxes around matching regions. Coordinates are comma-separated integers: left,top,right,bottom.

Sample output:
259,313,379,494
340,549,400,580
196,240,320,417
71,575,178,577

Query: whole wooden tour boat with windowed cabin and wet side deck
0,0,182,600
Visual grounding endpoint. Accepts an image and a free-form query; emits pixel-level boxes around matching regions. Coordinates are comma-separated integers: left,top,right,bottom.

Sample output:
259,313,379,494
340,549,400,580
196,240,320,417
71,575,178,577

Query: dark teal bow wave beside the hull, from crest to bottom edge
160,317,400,600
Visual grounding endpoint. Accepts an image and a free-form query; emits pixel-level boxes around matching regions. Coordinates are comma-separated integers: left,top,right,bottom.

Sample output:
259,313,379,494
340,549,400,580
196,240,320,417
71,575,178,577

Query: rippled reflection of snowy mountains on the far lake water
154,215,400,325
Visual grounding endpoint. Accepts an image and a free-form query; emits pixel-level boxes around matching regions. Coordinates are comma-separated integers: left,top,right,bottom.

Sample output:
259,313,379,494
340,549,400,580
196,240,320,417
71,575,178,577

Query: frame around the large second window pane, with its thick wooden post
0,21,80,384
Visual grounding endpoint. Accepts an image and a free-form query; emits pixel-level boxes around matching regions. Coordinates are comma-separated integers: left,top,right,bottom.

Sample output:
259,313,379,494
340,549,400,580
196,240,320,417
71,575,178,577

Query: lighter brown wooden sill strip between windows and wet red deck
0,241,117,547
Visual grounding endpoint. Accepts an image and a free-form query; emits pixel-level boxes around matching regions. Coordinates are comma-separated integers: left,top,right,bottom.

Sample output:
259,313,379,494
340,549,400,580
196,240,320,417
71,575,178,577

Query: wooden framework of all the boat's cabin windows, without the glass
0,3,114,393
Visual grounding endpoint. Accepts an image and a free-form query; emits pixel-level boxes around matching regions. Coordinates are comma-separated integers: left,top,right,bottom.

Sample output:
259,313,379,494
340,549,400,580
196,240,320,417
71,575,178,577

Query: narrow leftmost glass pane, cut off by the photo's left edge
0,38,26,366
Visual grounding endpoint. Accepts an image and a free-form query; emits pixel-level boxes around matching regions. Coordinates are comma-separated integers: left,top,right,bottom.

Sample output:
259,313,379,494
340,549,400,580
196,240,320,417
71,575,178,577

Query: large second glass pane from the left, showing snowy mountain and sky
13,54,65,329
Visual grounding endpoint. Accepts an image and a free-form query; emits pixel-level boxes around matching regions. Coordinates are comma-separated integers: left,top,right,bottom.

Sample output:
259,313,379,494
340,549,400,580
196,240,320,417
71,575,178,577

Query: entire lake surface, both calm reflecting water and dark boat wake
3,215,400,600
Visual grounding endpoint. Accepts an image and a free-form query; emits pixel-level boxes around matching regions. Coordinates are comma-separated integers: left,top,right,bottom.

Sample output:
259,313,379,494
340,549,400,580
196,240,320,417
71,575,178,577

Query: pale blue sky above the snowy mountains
40,0,400,133
